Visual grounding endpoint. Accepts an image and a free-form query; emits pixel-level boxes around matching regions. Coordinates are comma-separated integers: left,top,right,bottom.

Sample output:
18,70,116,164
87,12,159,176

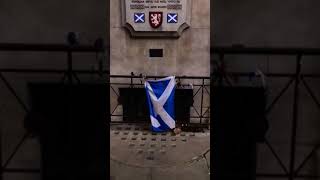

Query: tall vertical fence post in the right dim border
289,54,302,180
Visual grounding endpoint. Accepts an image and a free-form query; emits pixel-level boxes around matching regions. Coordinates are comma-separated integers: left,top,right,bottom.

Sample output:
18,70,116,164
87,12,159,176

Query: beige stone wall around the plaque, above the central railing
110,0,210,76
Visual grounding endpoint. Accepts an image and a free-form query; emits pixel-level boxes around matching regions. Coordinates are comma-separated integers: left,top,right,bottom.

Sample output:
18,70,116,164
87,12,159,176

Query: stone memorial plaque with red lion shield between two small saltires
121,0,192,37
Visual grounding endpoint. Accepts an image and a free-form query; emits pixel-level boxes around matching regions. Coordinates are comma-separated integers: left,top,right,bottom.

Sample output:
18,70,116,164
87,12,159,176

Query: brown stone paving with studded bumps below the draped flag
110,124,210,180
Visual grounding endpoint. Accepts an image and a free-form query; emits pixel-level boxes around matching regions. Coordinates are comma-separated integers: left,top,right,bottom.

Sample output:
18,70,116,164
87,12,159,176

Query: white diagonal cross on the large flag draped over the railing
146,76,175,129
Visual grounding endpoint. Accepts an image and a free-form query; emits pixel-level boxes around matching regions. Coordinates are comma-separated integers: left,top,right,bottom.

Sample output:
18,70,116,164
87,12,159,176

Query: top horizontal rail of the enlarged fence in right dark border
210,46,320,55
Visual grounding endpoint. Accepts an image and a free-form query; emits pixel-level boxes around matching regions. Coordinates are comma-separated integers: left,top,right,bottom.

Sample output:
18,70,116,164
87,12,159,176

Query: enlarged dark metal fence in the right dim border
211,47,320,180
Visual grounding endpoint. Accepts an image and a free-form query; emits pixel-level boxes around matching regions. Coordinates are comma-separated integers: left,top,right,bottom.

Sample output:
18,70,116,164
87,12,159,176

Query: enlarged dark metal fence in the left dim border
0,43,105,180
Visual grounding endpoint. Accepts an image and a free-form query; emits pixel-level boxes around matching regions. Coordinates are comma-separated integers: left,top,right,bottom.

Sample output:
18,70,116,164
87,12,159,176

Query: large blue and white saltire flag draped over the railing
145,76,176,132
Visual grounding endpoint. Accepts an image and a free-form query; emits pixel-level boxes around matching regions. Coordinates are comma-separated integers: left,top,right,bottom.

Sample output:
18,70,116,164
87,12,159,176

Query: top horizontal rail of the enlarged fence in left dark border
0,43,104,52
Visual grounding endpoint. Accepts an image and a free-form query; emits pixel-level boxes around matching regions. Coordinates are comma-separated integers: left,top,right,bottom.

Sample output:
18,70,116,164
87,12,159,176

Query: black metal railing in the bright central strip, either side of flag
110,75,210,126
